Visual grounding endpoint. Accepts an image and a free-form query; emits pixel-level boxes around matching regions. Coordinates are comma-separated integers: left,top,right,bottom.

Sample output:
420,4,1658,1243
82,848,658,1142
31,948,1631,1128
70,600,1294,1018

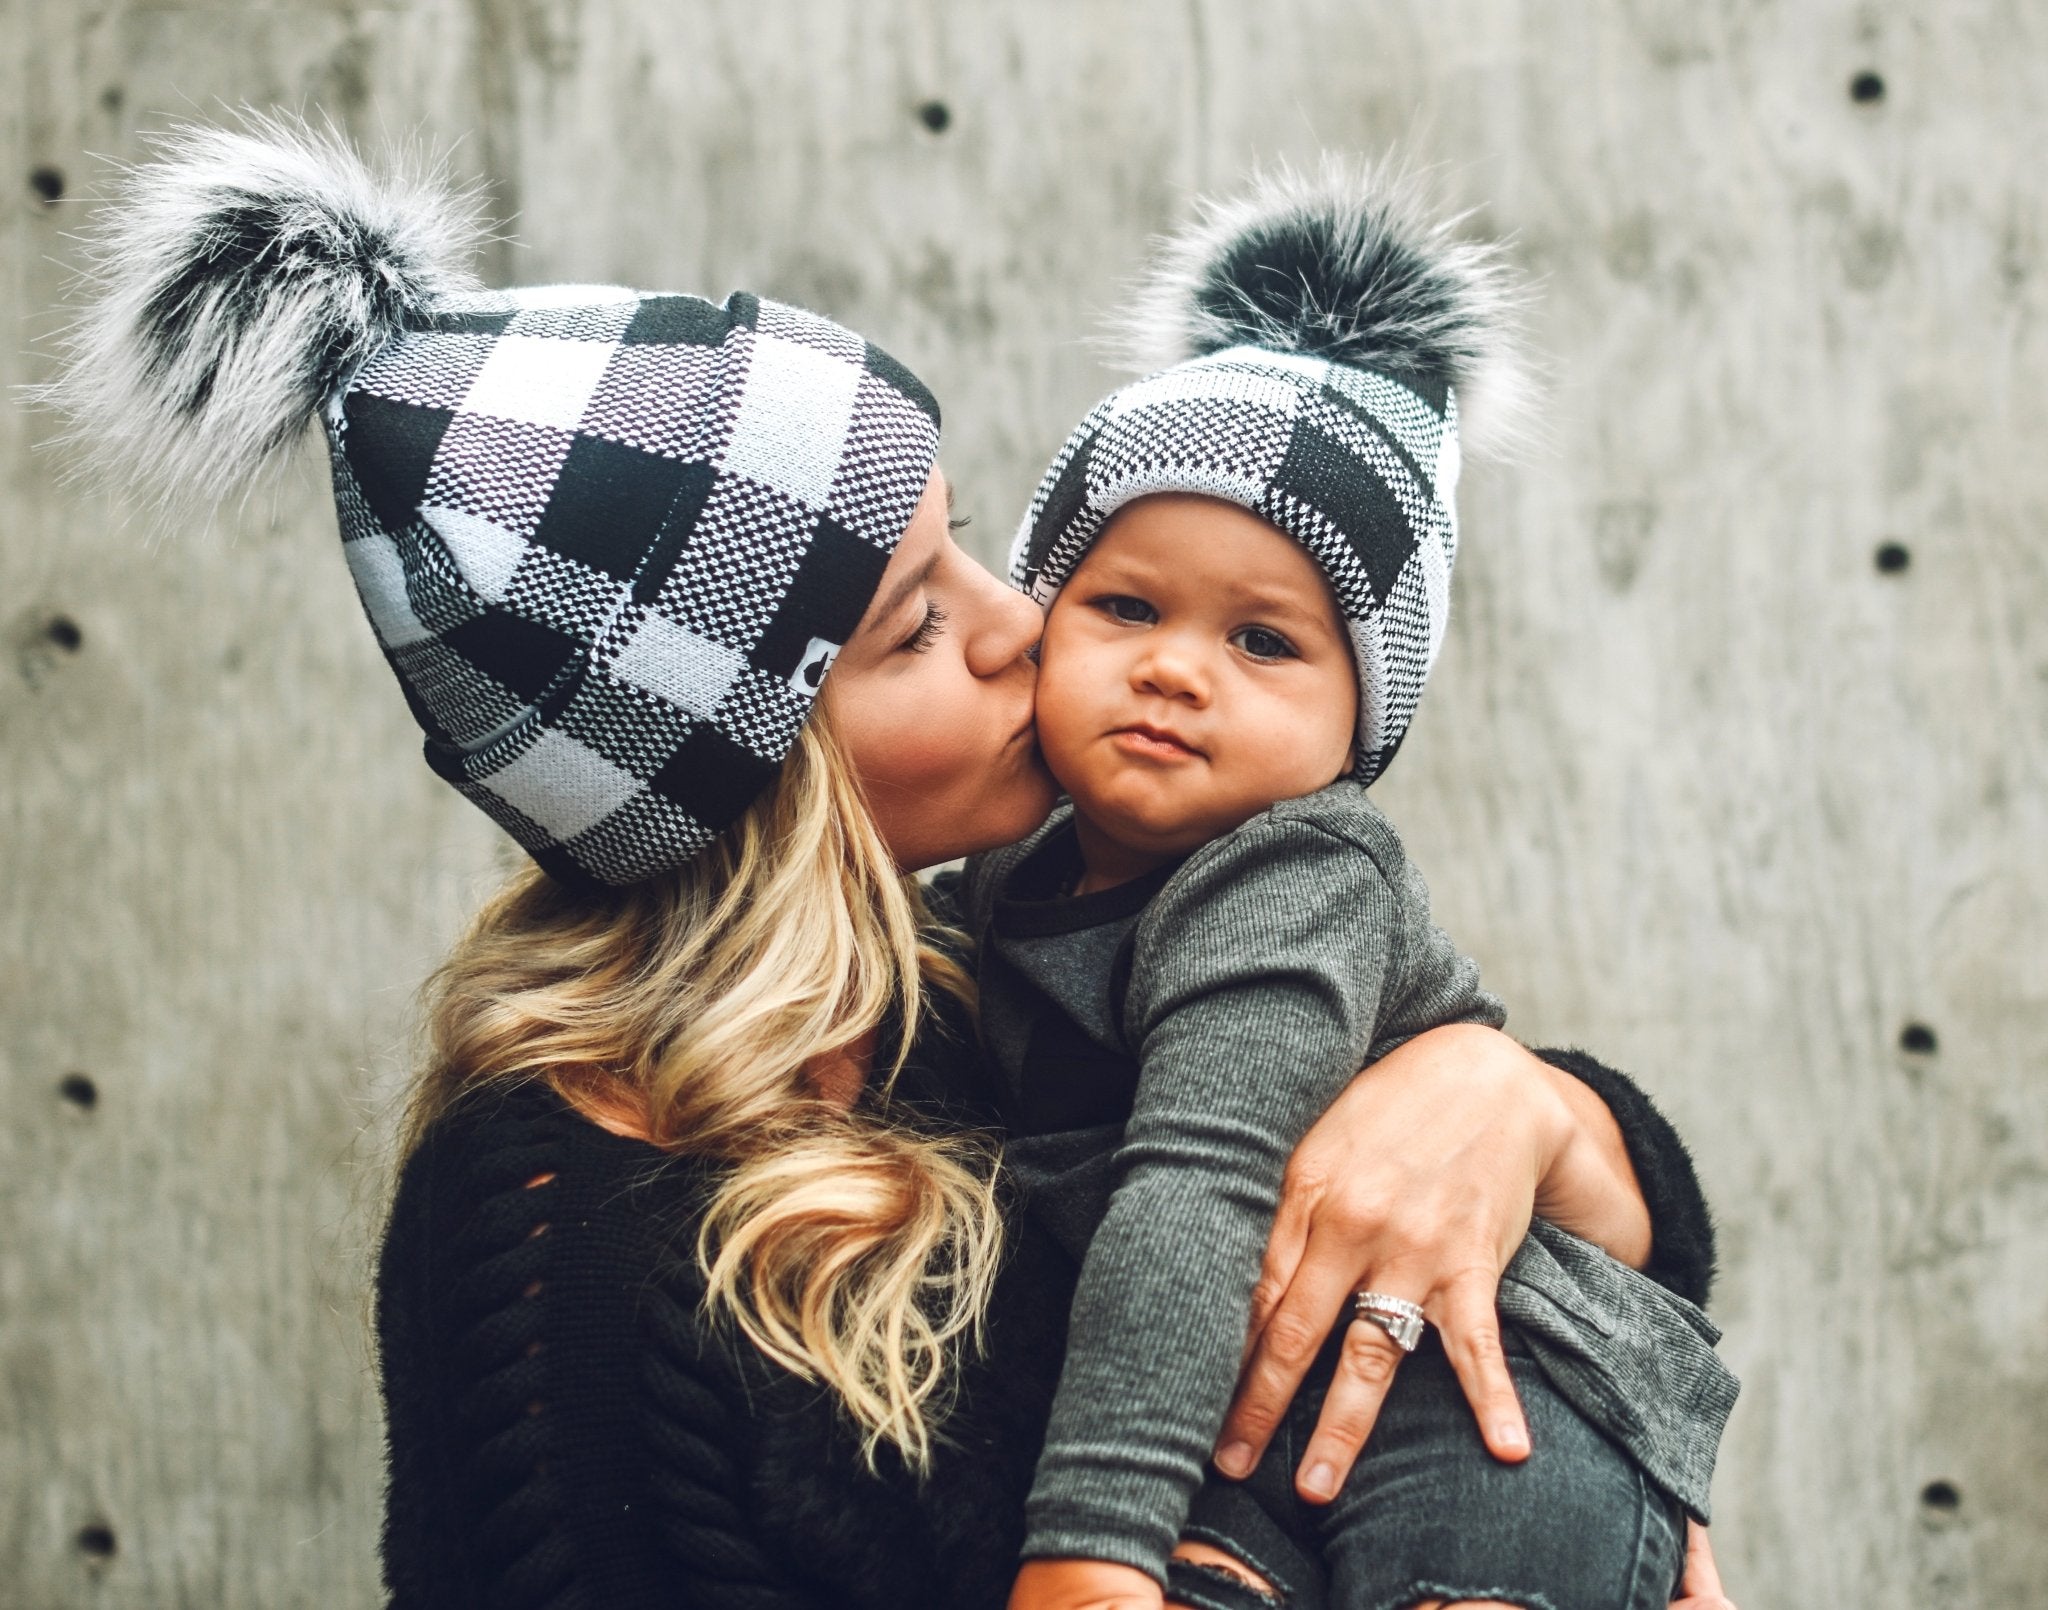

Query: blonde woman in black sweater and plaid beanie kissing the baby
51,125,1736,1606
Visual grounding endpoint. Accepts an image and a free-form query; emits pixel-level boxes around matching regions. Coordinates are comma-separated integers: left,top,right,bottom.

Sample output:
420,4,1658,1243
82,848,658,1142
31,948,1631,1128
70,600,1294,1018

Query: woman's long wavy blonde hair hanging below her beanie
406,713,1001,1471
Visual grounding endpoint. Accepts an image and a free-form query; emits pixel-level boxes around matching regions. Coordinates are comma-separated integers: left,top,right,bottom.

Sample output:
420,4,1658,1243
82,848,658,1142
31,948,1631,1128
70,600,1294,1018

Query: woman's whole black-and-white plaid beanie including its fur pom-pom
47,123,938,885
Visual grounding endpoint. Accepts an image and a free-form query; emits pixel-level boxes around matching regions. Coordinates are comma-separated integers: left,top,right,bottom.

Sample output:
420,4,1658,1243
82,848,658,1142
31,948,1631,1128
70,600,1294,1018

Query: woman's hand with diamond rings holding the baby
1217,1024,1649,1501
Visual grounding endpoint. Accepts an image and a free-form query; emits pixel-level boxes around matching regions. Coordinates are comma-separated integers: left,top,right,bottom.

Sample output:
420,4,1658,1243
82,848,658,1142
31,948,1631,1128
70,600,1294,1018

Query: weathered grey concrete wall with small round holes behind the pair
0,0,2048,1610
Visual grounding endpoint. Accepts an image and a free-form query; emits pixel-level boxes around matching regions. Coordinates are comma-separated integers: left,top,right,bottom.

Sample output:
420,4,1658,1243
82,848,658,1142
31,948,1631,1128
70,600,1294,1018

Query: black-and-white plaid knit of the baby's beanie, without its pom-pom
1010,346,1458,782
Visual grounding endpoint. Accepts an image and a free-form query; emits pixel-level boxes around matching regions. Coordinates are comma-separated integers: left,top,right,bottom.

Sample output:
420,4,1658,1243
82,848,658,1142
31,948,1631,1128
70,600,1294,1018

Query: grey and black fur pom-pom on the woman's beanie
31,115,481,514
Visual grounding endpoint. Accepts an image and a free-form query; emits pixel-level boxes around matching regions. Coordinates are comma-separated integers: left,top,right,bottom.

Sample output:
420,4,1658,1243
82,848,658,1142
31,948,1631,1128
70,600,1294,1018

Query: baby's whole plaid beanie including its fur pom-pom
1010,158,1522,782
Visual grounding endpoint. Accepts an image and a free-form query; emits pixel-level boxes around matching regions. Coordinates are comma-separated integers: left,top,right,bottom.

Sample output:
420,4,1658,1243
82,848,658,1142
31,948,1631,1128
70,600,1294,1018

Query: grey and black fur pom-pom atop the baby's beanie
1116,156,1534,453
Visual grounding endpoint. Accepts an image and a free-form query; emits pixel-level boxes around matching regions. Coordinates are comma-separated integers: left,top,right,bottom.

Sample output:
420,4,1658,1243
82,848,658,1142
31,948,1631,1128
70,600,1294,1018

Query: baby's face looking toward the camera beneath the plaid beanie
1038,494,1358,858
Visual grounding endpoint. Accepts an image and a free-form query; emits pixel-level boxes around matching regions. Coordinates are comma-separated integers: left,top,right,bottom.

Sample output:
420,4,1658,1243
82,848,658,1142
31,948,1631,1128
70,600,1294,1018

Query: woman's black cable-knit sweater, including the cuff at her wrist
377,1034,1712,1610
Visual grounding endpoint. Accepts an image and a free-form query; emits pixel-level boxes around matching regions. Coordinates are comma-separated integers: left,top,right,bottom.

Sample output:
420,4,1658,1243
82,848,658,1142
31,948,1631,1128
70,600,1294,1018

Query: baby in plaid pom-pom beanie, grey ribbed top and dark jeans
965,168,1735,1606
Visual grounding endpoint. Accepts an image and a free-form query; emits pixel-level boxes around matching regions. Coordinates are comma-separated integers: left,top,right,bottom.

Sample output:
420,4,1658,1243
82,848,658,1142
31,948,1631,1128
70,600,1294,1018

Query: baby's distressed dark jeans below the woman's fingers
1167,1329,1686,1610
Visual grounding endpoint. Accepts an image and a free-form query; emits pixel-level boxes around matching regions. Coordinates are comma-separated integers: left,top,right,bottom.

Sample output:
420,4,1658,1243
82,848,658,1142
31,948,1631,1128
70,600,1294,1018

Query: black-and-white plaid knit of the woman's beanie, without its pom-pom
326,285,938,885
